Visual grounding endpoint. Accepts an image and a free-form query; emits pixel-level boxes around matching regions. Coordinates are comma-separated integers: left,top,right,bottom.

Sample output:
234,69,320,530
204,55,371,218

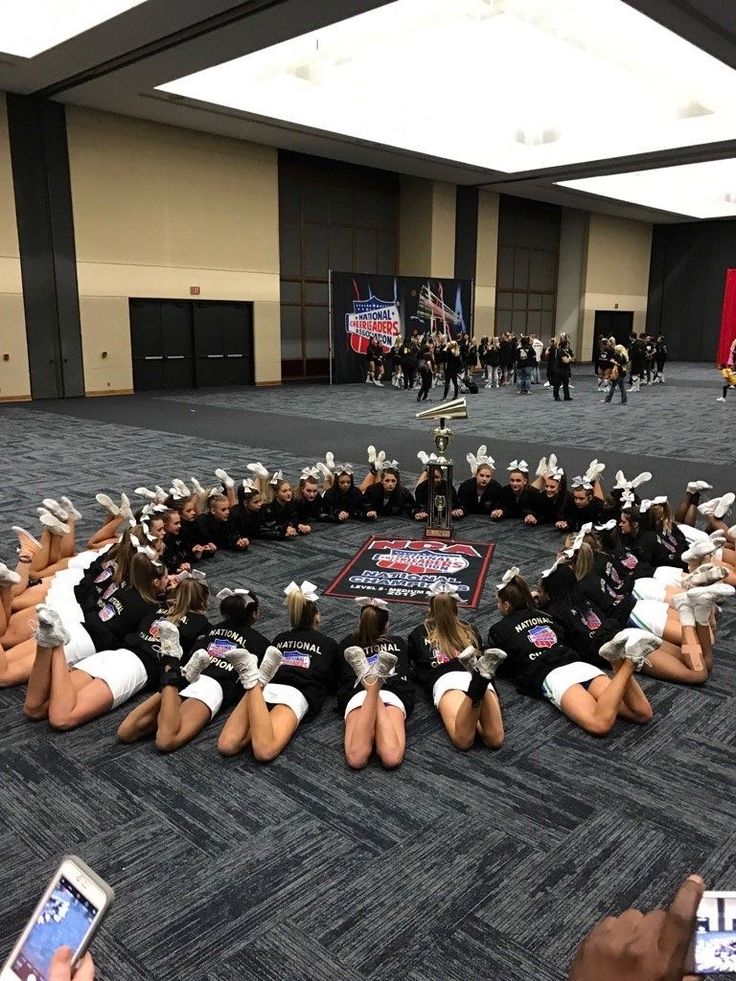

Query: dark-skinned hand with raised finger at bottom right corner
568,875,705,981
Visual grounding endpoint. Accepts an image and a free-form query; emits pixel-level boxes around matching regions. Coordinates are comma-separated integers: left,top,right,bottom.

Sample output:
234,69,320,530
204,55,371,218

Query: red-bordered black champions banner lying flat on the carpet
325,537,494,609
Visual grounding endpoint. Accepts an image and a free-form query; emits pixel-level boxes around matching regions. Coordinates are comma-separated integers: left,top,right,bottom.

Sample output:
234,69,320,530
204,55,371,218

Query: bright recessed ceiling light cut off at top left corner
0,0,151,58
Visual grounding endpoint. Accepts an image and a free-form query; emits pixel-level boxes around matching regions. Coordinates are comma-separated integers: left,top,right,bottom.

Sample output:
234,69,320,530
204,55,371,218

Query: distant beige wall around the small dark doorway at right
577,214,652,361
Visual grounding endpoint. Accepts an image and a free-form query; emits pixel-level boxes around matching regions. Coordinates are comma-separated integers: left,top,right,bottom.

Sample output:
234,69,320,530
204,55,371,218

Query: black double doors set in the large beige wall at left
130,300,253,392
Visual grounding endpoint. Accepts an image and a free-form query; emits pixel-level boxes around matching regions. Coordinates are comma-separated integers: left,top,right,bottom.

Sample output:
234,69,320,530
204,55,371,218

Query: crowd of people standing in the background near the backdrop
365,325,667,404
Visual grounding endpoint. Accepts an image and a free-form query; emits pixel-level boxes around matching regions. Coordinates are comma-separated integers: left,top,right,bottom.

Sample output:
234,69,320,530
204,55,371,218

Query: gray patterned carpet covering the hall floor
0,365,736,981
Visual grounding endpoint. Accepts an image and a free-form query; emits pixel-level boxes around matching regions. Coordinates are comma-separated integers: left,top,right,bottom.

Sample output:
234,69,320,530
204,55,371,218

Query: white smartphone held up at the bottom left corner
0,855,115,981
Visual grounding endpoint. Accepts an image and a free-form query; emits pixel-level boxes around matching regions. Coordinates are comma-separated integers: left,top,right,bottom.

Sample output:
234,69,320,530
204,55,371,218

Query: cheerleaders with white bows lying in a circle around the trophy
0,446,736,769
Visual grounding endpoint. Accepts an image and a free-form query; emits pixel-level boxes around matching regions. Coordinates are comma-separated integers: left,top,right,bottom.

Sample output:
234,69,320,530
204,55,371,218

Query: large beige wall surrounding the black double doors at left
67,107,281,394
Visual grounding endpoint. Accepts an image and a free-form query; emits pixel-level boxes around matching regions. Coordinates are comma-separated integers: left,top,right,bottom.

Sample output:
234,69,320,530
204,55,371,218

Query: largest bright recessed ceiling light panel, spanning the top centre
159,0,736,173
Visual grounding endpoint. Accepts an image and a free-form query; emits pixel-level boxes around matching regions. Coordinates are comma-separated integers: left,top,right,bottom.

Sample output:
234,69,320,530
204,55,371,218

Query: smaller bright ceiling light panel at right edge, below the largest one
558,157,736,218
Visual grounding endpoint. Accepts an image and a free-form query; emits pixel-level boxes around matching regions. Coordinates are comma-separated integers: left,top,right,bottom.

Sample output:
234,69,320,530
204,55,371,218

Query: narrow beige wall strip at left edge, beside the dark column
0,92,31,401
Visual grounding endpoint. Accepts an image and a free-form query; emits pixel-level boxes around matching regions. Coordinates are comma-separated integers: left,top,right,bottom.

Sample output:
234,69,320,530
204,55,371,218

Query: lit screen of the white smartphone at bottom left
11,875,97,981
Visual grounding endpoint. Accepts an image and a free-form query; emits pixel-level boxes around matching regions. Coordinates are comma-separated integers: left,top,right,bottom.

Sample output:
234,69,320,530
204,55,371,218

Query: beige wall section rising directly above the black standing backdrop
399,177,456,278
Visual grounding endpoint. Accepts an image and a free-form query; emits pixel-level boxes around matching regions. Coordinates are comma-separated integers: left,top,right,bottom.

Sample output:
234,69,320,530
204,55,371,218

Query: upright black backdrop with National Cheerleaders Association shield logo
331,272,473,385
